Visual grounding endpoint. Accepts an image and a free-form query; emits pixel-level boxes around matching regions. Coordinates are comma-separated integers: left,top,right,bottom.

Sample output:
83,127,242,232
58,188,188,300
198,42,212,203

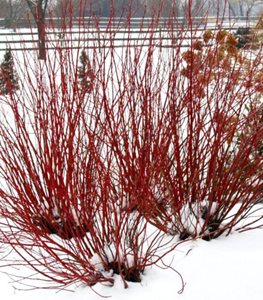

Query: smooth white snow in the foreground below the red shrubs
0,219,263,300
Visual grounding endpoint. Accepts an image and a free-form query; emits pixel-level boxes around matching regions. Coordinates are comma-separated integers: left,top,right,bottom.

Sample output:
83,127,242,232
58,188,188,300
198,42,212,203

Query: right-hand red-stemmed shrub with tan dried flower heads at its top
95,17,263,240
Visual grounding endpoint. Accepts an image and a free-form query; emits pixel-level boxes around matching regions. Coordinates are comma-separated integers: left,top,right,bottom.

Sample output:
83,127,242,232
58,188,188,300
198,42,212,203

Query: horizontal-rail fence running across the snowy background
0,17,257,51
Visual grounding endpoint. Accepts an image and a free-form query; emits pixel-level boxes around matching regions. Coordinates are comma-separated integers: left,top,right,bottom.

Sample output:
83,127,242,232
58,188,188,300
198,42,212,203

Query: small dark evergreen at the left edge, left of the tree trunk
0,49,19,95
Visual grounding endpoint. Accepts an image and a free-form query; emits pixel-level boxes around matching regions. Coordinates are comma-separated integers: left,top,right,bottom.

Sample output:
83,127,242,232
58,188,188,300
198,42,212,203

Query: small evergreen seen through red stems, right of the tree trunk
78,50,95,94
